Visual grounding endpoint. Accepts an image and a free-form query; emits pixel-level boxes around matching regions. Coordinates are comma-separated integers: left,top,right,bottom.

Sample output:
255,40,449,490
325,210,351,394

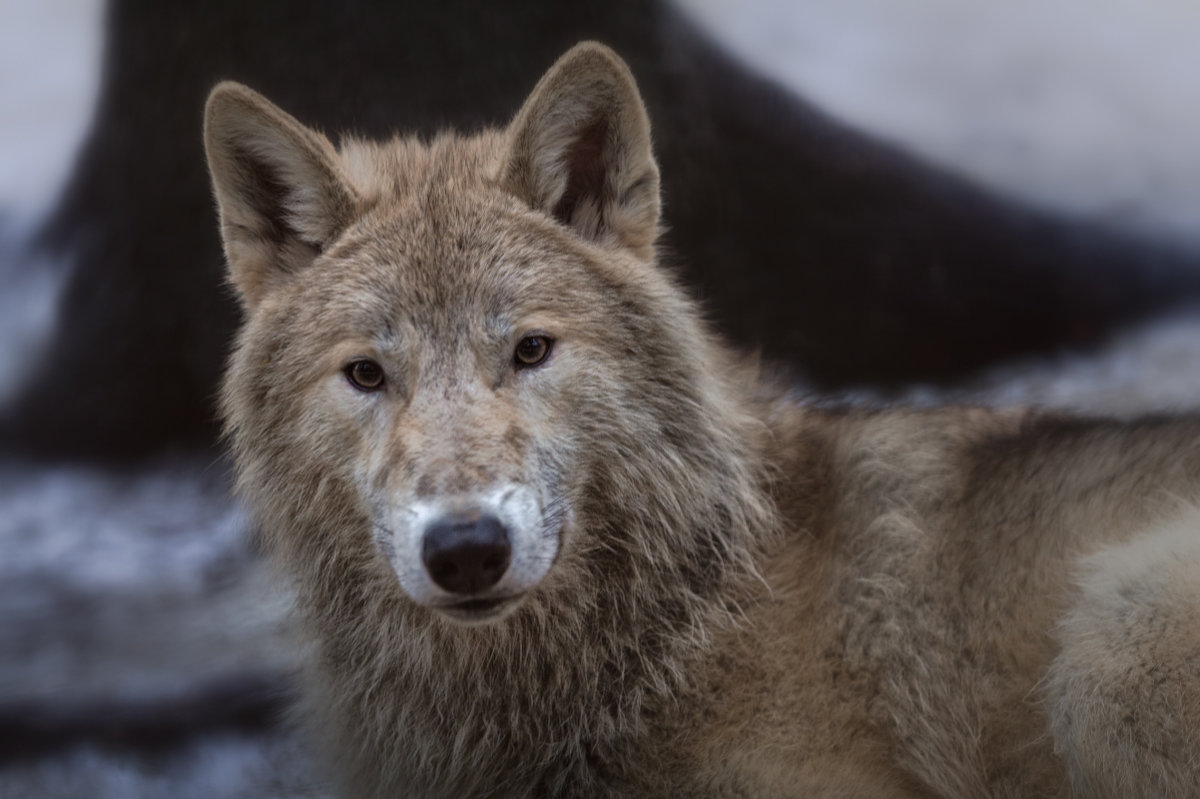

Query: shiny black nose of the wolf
421,515,512,594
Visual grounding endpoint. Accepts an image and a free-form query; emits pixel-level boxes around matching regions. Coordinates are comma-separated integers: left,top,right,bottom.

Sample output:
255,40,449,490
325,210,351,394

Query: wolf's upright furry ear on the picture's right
500,42,659,259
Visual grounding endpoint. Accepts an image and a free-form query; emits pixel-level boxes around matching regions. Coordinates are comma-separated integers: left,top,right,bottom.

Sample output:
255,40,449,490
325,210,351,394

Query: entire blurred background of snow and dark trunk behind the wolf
0,0,1200,799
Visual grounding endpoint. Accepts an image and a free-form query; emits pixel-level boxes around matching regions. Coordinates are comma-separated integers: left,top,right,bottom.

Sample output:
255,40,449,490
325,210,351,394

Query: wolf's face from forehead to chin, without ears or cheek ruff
248,183,657,623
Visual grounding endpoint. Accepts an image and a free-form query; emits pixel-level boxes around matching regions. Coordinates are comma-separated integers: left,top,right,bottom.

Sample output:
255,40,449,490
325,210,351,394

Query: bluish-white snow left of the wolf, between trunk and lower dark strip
0,459,300,705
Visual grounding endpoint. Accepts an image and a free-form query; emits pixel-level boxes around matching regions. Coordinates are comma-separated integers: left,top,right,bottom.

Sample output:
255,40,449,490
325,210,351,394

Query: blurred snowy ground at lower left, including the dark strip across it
0,458,316,799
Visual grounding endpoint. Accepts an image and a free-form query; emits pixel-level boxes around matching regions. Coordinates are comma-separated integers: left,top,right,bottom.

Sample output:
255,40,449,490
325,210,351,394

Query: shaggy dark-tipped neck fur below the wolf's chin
307,523,746,797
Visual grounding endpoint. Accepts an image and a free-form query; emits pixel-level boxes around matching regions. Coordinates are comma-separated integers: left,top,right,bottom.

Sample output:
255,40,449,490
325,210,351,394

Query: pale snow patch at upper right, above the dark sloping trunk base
677,0,1200,242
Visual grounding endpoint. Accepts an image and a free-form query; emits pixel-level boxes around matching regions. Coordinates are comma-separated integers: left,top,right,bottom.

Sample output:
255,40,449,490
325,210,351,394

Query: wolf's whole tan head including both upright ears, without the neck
205,44,766,624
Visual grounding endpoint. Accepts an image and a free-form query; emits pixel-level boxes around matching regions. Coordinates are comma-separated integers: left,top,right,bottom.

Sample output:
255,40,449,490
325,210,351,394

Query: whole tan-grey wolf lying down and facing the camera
204,43,1200,799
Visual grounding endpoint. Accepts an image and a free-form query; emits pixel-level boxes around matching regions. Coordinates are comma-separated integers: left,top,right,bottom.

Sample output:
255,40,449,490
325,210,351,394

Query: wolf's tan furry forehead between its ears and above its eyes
326,134,609,318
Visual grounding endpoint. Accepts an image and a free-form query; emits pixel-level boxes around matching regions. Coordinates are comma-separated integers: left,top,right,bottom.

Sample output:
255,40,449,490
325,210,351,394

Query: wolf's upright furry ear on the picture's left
204,82,359,307
